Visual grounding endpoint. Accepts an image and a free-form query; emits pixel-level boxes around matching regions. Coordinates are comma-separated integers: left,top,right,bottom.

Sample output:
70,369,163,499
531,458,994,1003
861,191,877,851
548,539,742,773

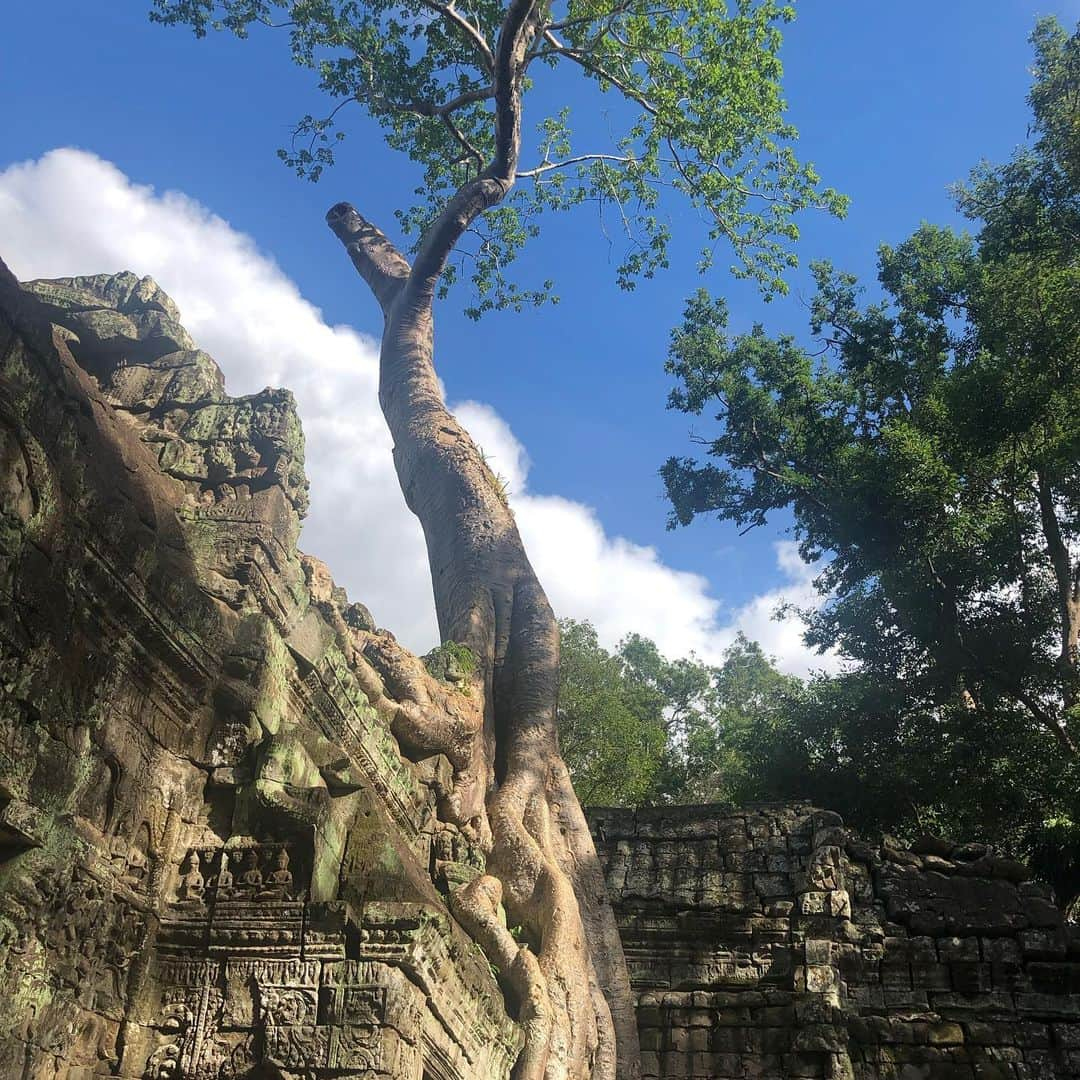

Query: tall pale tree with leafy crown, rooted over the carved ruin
154,0,842,1080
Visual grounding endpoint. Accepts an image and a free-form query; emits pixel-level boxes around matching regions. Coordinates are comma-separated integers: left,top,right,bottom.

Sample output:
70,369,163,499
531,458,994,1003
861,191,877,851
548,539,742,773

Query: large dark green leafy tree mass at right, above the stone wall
662,19,1080,891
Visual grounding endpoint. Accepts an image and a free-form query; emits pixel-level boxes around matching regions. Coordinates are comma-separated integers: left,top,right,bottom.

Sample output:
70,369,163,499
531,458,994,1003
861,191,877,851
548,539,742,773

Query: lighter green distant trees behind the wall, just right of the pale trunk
558,620,800,806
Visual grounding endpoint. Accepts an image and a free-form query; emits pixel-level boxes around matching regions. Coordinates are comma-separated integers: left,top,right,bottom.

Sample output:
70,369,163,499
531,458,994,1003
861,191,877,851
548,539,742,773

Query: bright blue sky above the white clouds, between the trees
0,0,1080,669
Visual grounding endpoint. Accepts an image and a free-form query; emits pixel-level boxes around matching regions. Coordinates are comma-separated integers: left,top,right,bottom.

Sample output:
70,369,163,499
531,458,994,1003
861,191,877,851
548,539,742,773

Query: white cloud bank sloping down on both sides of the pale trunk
0,149,835,673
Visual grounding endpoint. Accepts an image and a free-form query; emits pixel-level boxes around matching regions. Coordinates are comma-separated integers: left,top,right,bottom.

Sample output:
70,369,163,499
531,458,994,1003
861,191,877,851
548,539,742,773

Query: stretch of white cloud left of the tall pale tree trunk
0,149,437,649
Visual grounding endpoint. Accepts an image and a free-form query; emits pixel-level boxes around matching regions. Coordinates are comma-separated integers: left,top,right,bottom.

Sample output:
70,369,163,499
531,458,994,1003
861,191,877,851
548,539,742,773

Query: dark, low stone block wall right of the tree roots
590,806,1080,1080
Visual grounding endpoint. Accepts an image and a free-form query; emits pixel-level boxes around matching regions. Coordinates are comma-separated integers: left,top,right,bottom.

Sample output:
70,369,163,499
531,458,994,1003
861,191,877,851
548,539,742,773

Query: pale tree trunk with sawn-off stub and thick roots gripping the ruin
327,196,640,1080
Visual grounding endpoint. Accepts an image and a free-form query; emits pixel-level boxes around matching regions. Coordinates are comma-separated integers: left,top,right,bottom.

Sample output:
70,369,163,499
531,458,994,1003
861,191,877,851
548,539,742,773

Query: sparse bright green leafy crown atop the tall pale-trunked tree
151,0,845,316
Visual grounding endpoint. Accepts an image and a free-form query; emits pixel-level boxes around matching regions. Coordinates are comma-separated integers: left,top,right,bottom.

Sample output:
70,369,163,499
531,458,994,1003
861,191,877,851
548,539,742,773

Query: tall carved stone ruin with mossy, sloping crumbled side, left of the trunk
0,264,521,1080
